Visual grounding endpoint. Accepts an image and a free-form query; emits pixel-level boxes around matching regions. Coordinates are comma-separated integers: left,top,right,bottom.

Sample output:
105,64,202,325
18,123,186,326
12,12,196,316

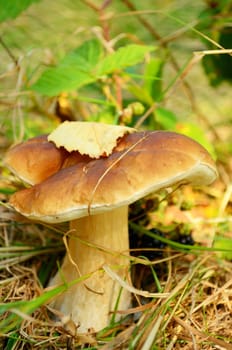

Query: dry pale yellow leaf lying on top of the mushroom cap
48,121,136,158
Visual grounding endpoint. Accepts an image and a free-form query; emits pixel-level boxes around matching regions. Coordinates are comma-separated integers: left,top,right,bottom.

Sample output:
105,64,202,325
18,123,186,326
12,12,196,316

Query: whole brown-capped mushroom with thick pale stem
6,122,217,331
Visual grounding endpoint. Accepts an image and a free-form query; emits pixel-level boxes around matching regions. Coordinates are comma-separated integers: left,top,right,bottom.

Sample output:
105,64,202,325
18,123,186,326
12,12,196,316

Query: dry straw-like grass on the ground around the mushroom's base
1,247,232,349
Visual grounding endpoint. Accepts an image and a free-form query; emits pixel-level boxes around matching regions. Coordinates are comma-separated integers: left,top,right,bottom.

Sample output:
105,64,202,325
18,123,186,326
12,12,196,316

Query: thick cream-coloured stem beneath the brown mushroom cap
50,206,130,332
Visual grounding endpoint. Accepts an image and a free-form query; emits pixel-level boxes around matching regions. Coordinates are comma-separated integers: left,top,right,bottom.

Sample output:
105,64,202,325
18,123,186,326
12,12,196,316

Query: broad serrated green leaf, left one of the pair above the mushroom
31,39,102,96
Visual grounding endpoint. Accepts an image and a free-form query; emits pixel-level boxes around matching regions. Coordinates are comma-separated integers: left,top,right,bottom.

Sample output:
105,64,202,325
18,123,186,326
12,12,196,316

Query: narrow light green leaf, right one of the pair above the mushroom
96,44,154,76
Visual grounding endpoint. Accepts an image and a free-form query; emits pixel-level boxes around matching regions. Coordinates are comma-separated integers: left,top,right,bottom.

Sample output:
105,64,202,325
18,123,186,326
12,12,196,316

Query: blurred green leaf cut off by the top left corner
0,0,40,22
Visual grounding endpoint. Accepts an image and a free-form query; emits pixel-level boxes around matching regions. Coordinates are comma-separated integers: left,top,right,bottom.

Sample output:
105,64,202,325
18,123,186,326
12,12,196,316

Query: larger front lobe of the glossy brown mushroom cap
7,131,217,222
